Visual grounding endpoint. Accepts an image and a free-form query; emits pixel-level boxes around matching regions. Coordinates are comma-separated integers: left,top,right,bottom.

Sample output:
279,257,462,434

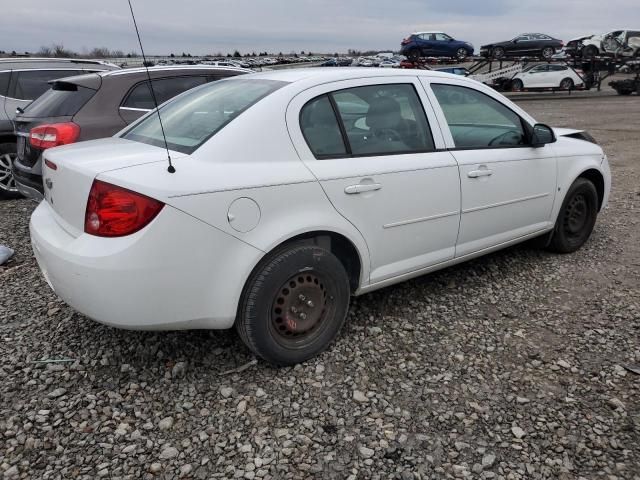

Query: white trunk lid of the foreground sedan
42,137,185,236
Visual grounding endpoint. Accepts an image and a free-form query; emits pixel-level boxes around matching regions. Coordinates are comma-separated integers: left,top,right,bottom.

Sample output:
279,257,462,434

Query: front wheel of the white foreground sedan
548,178,598,253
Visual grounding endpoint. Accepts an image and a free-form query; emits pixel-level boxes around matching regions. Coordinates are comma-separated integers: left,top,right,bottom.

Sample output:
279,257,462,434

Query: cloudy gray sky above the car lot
0,0,640,55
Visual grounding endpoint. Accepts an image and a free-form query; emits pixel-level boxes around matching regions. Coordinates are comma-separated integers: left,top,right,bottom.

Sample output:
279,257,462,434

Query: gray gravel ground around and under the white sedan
0,97,640,480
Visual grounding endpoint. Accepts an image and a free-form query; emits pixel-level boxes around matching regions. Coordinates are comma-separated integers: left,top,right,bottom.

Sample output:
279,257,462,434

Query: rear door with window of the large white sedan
287,76,460,284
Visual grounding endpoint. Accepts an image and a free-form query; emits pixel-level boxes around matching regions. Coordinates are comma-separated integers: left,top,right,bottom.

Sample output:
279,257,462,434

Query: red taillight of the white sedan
84,180,164,237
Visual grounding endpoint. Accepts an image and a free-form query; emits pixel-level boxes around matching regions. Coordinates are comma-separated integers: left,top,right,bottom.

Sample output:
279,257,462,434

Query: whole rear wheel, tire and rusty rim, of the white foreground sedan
236,243,350,366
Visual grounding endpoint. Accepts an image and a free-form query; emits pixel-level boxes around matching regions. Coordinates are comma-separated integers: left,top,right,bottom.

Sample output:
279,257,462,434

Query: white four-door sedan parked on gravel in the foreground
30,68,611,365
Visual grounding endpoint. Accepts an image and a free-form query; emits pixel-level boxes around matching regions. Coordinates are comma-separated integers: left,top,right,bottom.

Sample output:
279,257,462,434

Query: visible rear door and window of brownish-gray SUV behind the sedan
119,75,207,123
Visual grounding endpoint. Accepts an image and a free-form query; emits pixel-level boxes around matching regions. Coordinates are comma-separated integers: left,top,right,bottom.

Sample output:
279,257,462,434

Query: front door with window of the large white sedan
424,83,556,257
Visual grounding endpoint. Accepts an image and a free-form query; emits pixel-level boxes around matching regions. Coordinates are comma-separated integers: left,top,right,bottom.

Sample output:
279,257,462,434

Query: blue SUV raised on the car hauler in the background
400,32,473,61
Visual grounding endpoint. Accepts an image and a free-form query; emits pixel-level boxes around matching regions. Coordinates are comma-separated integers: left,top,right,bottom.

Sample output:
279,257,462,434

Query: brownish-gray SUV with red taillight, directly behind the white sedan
13,65,250,200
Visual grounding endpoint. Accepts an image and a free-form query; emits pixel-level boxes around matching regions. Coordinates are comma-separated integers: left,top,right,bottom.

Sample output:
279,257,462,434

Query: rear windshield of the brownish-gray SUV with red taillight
22,83,96,118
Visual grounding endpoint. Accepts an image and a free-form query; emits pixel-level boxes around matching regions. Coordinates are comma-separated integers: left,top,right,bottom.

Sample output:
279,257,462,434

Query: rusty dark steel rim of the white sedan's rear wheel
269,270,336,349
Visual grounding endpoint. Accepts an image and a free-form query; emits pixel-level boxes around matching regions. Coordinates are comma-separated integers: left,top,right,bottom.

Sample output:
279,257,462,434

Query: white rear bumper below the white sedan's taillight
29,202,262,330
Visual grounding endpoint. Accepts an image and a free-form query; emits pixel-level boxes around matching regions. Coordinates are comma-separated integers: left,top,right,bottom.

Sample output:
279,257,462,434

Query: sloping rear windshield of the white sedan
122,78,286,153
